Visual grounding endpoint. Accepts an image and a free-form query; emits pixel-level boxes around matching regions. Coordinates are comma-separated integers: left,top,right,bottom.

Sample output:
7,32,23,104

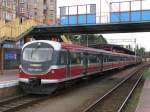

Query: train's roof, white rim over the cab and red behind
22,40,134,57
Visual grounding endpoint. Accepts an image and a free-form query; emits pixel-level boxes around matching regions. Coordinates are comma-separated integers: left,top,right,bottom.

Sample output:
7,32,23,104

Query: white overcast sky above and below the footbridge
57,0,150,51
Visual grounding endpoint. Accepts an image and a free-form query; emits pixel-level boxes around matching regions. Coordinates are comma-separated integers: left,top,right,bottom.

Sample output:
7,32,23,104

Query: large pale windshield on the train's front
23,47,53,62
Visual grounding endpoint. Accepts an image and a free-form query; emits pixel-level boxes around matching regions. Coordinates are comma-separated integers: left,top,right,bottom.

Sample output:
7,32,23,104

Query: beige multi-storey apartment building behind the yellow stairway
0,0,57,24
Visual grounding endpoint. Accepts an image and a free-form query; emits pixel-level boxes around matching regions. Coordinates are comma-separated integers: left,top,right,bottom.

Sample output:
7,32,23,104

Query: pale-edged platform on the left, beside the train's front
0,69,18,89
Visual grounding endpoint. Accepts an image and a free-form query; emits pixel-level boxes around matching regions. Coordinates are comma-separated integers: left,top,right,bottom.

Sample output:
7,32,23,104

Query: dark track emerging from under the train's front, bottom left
0,95,49,112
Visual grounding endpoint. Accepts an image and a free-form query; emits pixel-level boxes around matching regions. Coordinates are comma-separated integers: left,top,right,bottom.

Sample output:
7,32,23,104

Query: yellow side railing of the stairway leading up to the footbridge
0,18,40,40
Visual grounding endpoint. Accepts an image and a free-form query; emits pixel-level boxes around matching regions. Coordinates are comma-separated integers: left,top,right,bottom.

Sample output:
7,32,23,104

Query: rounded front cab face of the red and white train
18,41,61,94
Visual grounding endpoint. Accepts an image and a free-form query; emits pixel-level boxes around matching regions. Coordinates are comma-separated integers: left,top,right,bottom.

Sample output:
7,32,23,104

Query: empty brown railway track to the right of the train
82,66,147,112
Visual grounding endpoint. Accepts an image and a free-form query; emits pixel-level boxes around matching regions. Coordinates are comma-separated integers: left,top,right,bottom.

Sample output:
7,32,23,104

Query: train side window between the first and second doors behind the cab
70,52,81,64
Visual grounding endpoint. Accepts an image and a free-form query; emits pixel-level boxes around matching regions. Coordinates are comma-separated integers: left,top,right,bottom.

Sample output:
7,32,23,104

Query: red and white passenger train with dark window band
18,40,141,94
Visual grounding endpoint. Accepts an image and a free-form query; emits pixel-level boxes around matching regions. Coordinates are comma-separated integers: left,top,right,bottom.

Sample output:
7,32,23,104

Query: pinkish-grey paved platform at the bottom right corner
136,69,150,112
